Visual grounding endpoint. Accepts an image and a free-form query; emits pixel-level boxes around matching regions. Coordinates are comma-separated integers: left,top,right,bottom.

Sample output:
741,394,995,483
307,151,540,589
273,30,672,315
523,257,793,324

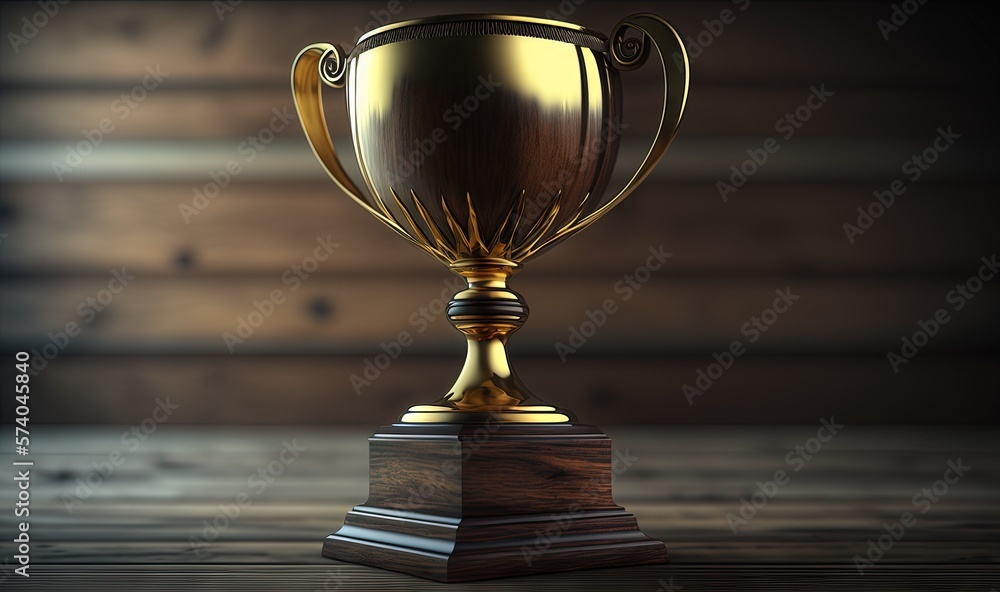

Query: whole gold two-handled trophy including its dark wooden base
292,14,688,582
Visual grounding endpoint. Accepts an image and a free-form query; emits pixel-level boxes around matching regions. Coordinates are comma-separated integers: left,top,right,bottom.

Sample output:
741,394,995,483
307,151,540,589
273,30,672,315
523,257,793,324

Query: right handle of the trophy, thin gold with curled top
560,13,689,236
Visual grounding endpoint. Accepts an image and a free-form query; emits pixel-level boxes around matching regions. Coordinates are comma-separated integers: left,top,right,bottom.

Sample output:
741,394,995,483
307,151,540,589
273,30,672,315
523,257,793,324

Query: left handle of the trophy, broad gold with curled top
292,43,384,219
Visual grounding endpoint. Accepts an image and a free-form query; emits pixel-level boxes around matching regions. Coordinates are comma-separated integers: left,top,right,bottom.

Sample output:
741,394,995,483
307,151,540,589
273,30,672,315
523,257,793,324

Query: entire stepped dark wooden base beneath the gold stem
323,423,669,582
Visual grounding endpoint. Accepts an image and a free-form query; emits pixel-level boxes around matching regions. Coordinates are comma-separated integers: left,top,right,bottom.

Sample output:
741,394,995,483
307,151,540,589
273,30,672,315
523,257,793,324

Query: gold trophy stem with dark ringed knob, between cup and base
400,258,575,423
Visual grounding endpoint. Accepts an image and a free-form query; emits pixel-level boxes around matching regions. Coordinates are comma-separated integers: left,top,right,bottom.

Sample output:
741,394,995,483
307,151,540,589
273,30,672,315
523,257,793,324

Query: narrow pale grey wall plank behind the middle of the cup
0,136,996,183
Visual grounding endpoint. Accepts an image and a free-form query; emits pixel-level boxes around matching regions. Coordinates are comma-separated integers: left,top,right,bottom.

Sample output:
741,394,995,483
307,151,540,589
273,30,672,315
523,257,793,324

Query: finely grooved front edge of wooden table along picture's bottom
3,559,1000,592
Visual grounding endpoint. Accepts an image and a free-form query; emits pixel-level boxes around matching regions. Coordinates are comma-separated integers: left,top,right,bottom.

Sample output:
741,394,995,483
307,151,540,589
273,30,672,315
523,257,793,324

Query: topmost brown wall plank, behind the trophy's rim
0,1,994,86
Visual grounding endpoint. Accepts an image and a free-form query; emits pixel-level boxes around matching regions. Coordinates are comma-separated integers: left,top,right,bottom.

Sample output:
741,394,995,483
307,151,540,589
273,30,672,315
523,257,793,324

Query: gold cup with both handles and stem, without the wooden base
292,14,688,423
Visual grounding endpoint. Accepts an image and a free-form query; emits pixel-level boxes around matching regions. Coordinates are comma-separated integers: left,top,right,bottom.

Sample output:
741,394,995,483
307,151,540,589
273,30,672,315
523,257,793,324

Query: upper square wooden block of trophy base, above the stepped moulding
365,423,616,518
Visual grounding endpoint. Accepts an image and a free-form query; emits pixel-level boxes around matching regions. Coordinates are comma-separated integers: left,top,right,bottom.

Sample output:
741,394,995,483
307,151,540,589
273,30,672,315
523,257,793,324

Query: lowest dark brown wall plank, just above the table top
0,349,1000,424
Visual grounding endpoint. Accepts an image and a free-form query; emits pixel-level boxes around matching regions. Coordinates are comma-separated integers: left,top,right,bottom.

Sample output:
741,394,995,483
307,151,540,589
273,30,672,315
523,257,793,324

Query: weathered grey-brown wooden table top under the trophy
0,421,1000,592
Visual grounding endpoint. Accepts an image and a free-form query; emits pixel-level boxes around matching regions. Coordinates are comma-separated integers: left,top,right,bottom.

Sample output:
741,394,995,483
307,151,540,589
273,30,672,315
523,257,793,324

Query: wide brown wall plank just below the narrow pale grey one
0,180,1000,276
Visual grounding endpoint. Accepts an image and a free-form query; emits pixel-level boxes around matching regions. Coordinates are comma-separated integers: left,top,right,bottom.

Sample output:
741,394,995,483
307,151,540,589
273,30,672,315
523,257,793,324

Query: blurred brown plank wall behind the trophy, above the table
0,0,1000,426
